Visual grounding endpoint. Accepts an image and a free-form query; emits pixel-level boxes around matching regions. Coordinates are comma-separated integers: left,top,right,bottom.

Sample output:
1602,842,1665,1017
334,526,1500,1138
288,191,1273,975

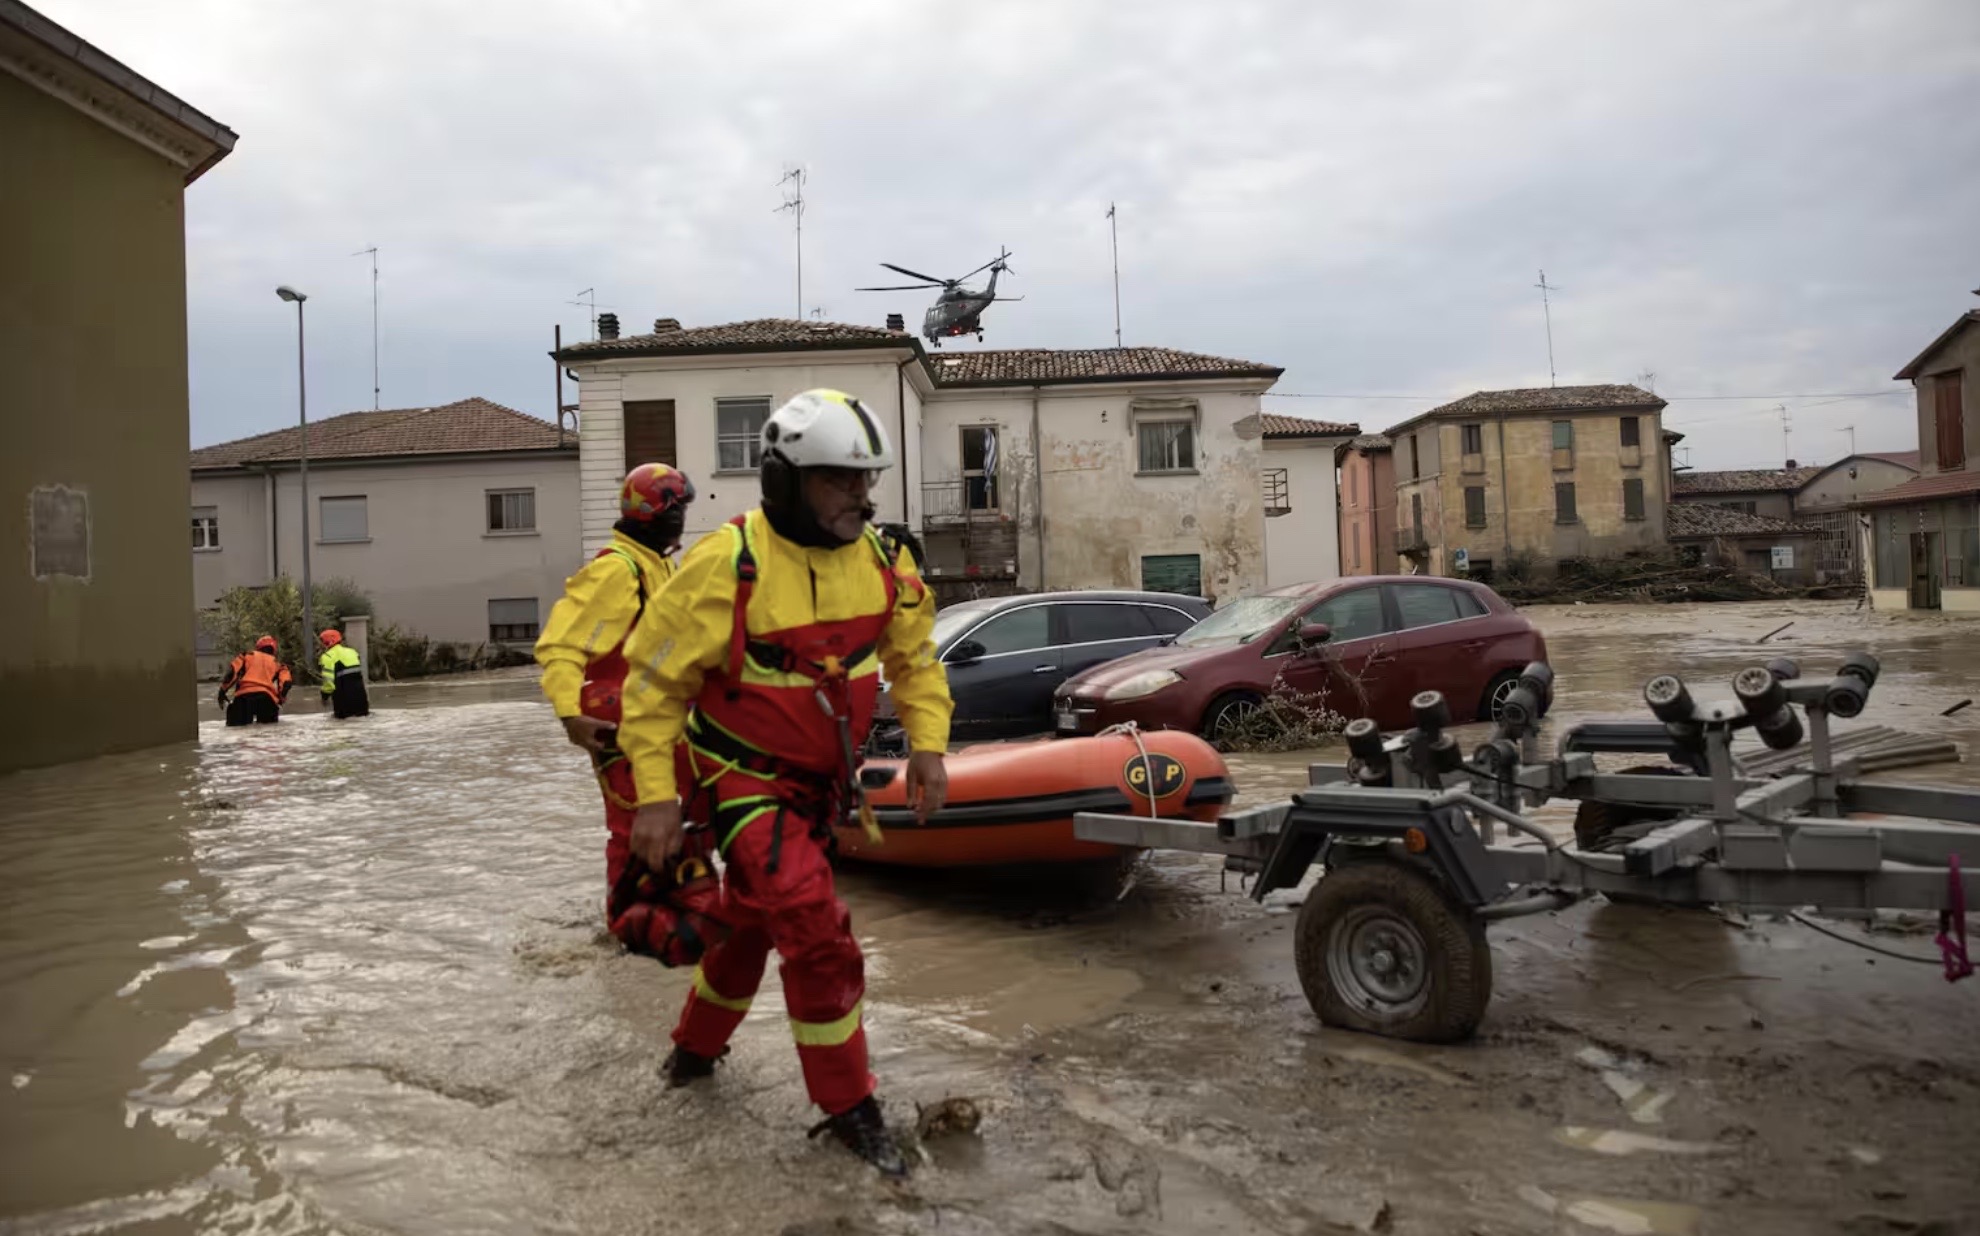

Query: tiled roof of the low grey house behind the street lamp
192,398,576,469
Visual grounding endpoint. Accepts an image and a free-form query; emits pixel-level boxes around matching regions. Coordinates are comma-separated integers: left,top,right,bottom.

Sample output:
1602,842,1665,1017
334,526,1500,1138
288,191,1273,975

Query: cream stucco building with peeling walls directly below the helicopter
556,315,1352,598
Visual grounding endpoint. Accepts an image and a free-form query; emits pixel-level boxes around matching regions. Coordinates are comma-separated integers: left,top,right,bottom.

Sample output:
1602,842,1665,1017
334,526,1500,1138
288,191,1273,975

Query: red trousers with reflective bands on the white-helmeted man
673,773,873,1115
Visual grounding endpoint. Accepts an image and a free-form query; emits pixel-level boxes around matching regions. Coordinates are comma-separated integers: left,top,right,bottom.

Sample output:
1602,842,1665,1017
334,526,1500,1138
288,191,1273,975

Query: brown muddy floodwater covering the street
0,604,1980,1236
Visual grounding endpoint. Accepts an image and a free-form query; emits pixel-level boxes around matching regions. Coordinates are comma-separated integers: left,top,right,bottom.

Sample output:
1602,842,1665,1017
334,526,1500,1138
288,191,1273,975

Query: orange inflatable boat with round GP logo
834,729,1232,868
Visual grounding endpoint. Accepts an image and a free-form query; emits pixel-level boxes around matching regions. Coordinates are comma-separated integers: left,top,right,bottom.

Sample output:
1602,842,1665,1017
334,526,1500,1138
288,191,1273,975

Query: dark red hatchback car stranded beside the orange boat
1053,574,1546,739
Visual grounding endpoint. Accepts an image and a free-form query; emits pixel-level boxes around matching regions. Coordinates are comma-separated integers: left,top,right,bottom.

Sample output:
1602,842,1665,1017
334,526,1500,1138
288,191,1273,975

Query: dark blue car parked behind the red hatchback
875,592,1210,749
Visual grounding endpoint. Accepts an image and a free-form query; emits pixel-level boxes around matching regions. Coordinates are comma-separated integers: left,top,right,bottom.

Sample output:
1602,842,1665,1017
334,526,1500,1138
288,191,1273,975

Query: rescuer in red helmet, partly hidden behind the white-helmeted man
537,464,695,887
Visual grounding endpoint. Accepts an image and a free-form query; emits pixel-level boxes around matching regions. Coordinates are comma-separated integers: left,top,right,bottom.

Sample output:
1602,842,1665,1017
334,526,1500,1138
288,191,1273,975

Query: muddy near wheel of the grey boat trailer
1293,860,1491,1042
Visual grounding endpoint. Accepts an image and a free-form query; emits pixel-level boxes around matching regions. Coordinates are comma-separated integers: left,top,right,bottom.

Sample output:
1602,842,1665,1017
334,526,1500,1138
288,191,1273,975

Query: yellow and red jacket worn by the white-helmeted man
620,509,954,802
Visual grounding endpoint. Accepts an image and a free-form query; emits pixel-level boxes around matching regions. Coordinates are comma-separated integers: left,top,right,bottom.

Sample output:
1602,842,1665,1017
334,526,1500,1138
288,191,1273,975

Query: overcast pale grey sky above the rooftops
36,0,1980,467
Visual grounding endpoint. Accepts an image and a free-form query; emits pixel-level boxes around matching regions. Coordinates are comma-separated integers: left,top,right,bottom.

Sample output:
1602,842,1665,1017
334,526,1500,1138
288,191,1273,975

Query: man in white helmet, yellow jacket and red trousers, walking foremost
620,390,952,1177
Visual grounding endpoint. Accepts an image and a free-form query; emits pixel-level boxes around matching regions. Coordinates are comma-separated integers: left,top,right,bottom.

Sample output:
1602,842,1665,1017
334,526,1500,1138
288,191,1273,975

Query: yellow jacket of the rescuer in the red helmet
537,533,673,717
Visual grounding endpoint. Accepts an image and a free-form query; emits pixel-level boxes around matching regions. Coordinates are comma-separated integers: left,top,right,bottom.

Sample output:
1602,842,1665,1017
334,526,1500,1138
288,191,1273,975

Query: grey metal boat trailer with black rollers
1073,652,1980,1042
